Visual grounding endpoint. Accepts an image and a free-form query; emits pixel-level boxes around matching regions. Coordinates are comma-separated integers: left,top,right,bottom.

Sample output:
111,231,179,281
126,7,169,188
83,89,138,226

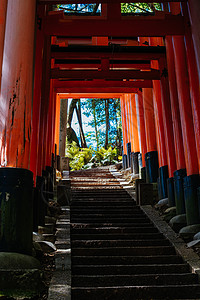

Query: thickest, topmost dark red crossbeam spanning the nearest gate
43,15,185,38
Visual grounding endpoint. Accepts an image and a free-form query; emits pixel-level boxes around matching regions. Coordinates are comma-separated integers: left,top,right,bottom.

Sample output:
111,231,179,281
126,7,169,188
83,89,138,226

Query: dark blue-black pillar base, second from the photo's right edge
174,169,187,215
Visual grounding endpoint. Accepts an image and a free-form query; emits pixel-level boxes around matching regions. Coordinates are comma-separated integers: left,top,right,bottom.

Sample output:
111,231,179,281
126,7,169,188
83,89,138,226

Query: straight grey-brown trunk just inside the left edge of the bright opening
59,99,68,157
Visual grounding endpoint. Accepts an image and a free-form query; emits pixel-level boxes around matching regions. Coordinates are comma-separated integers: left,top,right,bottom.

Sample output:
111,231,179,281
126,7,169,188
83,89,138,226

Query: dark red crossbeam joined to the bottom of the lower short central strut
51,69,160,80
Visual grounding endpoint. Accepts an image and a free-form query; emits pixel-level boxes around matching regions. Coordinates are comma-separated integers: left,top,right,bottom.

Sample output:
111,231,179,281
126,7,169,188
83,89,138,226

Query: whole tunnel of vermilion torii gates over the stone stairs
0,0,200,246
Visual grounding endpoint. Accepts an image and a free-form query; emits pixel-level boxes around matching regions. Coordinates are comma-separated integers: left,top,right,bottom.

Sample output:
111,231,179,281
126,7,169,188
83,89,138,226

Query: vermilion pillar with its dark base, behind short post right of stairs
143,88,159,183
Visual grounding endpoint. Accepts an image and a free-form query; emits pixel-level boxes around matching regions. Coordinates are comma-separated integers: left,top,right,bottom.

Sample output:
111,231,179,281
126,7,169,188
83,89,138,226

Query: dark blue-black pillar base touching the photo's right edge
184,174,200,225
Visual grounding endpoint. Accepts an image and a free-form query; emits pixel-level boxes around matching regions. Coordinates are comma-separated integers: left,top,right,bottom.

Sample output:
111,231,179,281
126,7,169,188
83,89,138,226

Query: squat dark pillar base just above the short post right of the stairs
145,151,159,183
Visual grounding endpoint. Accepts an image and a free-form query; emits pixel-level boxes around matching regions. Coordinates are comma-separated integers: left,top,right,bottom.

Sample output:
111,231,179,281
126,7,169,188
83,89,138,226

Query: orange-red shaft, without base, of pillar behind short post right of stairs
142,89,157,152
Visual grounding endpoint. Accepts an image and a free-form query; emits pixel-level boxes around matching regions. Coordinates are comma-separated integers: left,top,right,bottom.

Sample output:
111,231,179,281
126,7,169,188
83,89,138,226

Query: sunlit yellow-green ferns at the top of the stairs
66,142,118,171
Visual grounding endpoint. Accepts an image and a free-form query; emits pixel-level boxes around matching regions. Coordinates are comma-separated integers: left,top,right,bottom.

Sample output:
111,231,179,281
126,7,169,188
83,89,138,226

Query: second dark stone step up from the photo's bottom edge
72,273,198,288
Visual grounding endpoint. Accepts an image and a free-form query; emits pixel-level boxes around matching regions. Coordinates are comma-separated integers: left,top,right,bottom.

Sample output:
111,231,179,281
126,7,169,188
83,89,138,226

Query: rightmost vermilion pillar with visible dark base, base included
173,37,200,225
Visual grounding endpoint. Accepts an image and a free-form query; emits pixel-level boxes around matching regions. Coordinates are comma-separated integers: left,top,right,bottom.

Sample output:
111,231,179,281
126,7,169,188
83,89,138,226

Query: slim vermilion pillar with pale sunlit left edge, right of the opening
135,92,147,167
